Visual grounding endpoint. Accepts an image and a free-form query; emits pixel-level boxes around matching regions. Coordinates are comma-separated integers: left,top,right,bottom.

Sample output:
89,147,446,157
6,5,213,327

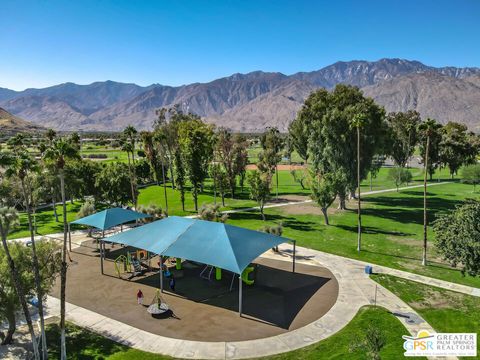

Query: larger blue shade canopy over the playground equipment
107,216,290,274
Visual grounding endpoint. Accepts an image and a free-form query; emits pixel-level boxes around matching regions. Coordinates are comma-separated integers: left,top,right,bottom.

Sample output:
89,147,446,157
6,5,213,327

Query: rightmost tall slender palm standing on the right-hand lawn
418,119,442,266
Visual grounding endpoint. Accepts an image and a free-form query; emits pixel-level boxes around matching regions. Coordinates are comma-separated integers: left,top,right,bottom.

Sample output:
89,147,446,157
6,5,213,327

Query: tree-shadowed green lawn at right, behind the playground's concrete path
229,183,480,287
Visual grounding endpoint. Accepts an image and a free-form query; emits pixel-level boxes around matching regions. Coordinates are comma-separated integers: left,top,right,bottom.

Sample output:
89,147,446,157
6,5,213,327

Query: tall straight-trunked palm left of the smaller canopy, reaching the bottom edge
43,138,80,360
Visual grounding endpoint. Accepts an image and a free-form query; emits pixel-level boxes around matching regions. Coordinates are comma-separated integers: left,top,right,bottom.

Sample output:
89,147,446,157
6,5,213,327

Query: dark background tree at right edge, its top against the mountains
440,121,476,179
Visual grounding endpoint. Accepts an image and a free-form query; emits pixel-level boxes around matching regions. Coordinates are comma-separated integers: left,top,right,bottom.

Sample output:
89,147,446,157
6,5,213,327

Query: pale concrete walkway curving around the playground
38,245,472,359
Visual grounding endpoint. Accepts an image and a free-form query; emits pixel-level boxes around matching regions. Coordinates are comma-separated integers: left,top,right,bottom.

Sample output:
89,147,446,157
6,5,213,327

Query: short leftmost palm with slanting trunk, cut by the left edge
0,207,39,359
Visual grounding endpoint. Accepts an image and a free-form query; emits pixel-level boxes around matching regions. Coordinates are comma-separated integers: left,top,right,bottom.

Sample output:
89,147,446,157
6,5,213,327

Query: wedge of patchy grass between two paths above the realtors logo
372,274,480,353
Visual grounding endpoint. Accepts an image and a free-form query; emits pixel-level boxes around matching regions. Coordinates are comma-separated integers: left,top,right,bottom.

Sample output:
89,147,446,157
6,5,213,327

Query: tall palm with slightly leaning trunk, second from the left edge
5,153,48,359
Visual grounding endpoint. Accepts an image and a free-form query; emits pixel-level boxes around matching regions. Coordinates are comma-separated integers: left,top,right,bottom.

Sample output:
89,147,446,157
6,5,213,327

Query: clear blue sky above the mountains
0,0,480,90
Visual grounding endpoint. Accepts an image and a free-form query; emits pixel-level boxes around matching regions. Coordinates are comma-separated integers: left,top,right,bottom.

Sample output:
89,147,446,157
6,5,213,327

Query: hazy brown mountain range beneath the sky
0,59,480,132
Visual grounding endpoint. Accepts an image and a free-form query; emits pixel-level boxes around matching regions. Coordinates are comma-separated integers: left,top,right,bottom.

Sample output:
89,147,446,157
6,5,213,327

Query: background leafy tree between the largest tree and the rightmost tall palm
386,110,422,167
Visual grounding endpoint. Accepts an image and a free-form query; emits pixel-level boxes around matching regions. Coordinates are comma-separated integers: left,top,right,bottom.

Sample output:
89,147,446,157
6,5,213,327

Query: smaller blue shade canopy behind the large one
70,208,151,230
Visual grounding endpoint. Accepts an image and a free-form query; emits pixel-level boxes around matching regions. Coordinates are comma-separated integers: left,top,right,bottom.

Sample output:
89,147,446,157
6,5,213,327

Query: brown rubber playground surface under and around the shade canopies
51,240,338,341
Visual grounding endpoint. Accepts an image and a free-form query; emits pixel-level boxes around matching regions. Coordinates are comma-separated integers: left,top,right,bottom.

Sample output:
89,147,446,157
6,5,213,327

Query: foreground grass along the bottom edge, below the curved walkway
47,306,416,360
